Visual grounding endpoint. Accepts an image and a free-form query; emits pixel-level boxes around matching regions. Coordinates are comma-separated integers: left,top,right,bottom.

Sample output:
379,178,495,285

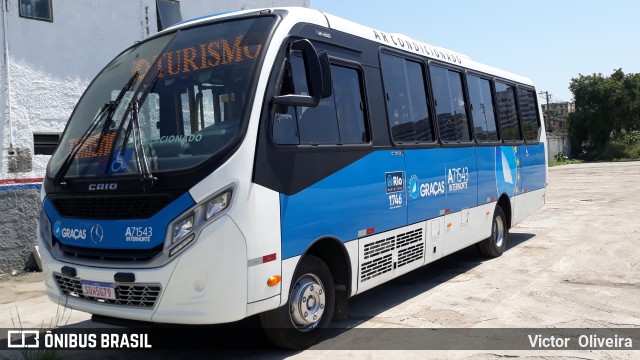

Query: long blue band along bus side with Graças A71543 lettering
280,143,546,259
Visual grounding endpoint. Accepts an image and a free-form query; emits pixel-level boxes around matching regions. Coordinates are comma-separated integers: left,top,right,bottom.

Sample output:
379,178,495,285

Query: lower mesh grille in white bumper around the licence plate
53,274,162,309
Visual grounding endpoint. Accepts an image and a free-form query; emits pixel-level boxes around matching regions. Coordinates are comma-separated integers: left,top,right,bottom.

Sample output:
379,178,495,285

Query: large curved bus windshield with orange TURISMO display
49,17,274,182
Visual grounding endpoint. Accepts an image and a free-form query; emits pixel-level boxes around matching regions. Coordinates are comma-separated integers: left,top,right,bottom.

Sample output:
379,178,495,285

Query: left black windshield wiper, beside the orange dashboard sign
53,71,139,185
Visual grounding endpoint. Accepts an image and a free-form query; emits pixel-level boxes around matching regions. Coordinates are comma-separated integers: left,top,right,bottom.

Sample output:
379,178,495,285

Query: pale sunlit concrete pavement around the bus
0,162,640,359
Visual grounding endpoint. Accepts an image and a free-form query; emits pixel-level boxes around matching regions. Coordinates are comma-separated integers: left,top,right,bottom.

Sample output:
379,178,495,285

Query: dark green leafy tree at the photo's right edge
568,69,640,160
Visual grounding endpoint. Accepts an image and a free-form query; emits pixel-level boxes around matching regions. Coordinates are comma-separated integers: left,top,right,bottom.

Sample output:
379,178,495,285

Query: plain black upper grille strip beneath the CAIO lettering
51,195,171,220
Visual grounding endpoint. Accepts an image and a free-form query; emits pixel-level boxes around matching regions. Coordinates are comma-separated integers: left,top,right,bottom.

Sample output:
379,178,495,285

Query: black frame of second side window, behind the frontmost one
378,46,442,149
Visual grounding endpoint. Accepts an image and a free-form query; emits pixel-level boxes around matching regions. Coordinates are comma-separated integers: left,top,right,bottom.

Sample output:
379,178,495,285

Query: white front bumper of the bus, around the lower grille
39,216,247,324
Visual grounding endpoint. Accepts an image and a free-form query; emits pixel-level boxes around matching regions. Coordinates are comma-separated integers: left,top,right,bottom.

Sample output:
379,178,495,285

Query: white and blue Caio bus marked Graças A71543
38,8,547,348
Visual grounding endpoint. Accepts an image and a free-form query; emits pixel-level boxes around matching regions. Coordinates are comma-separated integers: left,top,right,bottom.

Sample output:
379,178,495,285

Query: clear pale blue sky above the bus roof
311,0,640,102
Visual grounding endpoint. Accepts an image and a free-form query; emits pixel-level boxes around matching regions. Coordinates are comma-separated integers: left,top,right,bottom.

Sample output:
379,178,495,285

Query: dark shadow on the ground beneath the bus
51,233,535,360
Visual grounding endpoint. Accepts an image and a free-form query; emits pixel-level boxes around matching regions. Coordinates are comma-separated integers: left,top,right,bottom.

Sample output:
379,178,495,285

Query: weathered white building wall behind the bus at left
0,0,310,273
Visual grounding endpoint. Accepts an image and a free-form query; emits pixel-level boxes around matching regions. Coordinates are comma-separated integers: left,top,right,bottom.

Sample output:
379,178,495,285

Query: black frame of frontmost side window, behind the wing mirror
265,35,373,151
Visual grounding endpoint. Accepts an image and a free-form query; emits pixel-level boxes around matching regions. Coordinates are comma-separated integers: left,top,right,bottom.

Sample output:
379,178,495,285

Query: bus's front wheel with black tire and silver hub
260,255,335,350
